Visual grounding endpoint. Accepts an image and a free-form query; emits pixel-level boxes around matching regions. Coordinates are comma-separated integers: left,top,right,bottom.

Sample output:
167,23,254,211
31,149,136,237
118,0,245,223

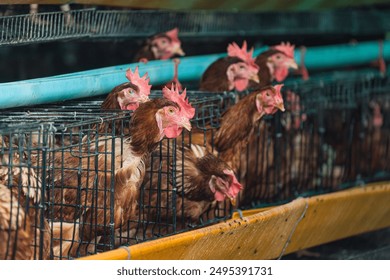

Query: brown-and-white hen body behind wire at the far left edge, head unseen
0,135,50,259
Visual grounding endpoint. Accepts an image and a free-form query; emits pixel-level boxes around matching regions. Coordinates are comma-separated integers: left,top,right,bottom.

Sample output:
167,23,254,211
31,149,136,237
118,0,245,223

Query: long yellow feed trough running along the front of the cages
80,182,390,260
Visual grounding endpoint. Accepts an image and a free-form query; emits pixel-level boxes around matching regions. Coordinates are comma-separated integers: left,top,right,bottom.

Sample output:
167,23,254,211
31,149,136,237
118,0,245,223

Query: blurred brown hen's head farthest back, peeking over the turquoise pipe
134,28,185,62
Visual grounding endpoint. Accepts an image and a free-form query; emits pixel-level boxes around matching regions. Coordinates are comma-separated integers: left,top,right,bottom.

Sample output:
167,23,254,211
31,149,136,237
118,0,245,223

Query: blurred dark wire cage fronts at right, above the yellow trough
236,69,390,208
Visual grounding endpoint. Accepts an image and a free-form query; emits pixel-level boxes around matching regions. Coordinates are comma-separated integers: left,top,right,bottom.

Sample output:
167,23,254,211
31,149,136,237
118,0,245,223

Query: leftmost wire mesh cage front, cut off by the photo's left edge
0,122,54,259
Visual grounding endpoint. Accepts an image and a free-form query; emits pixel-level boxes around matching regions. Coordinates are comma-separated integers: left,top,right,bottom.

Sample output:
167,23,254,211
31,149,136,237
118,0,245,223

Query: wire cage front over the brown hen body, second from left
47,115,124,258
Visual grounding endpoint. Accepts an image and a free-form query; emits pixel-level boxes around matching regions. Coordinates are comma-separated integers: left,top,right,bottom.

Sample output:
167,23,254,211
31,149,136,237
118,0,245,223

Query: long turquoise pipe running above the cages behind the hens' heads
0,40,390,109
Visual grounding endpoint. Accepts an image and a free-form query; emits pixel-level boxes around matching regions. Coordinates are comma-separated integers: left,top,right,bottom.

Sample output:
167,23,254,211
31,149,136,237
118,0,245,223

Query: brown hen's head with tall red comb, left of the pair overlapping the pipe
199,41,259,92
